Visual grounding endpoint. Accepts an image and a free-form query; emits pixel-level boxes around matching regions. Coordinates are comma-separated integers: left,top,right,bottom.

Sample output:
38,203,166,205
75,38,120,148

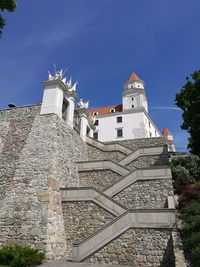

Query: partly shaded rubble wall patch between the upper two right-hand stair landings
126,154,169,170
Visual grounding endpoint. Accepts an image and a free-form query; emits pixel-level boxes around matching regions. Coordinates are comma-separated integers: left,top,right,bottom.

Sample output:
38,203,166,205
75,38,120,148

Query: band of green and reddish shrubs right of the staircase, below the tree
171,155,200,267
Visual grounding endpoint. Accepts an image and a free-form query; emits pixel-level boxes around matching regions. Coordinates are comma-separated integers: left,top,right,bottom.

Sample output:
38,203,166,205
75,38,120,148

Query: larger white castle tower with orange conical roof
122,72,148,113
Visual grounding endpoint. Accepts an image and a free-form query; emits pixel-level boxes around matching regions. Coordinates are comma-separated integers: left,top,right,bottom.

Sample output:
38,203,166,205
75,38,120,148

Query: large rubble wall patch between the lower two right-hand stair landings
113,179,173,209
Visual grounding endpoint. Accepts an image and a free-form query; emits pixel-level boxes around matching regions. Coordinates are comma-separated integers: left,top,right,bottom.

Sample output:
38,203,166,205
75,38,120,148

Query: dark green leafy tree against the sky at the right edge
176,70,200,156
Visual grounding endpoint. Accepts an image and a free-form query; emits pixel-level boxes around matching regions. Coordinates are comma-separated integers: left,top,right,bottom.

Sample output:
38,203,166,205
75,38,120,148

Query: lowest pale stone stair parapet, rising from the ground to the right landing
72,209,175,262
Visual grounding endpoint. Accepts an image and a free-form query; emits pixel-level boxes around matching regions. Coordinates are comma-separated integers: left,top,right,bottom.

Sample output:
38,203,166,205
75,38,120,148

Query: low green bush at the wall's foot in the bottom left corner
0,245,45,267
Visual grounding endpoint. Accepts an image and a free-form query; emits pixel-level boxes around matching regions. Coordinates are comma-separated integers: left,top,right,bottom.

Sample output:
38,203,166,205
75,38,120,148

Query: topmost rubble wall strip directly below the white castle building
105,137,165,151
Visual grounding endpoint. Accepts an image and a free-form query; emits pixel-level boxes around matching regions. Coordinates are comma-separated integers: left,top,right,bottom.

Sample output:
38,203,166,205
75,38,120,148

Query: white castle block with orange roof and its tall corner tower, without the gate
90,73,161,142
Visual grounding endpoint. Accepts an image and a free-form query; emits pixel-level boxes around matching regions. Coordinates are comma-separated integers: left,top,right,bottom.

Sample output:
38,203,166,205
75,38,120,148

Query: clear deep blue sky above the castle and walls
0,0,200,151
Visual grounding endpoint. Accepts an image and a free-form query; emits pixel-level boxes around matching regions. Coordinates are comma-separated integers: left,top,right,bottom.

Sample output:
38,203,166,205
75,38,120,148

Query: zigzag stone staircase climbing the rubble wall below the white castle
61,138,175,267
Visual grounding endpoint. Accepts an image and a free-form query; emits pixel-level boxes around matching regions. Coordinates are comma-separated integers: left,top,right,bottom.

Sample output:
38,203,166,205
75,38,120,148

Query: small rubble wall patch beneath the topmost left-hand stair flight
87,144,126,162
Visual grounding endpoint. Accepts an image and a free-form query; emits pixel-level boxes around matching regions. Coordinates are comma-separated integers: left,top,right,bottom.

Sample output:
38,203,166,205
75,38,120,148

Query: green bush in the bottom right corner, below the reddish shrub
180,203,200,266
